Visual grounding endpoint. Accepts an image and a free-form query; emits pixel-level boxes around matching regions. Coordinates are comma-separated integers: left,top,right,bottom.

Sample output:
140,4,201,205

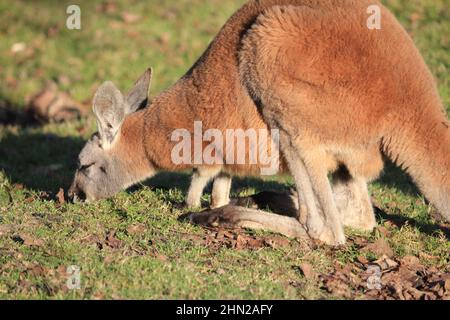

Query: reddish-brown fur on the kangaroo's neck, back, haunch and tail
102,0,450,236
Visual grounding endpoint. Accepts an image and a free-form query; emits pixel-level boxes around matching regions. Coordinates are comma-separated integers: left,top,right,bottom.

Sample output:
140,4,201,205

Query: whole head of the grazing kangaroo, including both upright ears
69,69,153,201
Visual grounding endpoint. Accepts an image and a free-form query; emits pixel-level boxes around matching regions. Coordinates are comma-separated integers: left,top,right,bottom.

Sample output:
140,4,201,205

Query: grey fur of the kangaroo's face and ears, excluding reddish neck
69,69,152,201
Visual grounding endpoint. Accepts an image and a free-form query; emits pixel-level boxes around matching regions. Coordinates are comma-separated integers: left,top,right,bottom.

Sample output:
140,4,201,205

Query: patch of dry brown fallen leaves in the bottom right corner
312,251,450,300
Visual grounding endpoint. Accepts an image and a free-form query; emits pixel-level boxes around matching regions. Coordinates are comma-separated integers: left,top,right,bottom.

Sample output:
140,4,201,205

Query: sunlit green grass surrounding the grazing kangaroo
0,0,450,299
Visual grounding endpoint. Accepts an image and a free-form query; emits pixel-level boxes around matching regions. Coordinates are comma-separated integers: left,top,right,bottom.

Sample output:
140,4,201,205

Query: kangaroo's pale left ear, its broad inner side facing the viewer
93,81,128,148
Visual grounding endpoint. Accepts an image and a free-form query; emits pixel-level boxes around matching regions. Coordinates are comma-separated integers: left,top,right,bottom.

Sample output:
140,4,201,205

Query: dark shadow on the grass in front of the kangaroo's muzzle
0,129,85,193
